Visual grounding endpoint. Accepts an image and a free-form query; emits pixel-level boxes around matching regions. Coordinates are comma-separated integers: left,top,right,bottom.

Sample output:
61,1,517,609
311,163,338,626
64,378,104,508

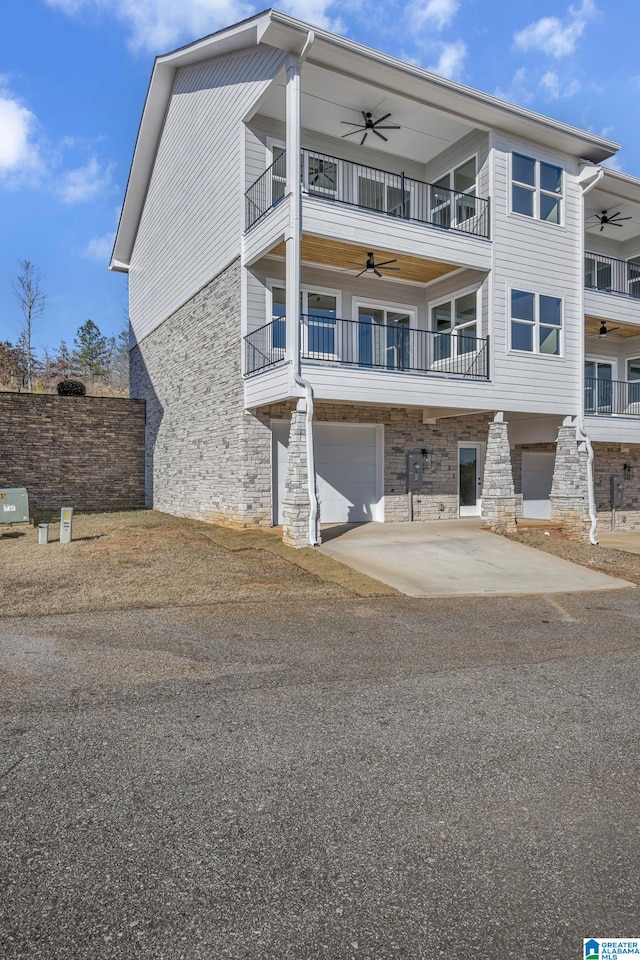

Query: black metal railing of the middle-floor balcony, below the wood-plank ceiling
245,314,489,380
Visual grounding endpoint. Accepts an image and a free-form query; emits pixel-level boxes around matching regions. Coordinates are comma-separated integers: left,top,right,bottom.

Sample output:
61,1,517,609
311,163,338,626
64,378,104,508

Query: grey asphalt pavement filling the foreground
0,590,640,960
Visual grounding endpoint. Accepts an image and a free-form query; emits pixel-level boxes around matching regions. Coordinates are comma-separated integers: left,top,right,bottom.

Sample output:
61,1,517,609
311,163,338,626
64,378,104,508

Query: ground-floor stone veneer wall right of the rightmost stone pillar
593,443,640,530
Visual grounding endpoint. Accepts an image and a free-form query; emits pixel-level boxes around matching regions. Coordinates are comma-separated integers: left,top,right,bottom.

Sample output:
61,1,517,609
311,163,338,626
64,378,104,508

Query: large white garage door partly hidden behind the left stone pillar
271,422,382,523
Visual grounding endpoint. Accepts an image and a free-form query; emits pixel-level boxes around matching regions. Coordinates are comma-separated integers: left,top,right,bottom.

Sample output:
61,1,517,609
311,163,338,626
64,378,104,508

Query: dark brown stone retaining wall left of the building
0,393,145,510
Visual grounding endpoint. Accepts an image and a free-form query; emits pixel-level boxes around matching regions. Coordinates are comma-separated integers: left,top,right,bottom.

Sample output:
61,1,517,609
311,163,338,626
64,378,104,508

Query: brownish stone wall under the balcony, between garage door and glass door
266,401,489,522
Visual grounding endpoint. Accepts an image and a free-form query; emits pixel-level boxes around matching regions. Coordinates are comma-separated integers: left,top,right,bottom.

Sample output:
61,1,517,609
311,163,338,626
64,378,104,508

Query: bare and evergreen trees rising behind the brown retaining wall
0,260,129,396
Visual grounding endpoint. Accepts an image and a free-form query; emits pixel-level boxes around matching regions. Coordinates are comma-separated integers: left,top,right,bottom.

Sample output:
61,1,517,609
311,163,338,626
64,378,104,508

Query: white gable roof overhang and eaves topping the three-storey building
110,9,619,271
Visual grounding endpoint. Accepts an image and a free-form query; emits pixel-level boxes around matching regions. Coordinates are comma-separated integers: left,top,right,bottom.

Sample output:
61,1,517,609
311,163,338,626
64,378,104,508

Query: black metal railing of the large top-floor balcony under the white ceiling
245,150,489,238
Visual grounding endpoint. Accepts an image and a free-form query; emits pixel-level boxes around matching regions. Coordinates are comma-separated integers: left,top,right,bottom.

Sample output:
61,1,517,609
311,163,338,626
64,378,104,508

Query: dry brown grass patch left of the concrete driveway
0,510,396,616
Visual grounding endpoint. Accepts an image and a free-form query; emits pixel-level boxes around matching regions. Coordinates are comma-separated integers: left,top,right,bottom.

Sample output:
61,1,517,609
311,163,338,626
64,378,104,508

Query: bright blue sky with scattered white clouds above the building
0,0,640,350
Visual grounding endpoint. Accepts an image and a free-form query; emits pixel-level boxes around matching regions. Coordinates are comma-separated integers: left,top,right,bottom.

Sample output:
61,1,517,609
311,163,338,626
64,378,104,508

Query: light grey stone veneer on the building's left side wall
131,260,271,525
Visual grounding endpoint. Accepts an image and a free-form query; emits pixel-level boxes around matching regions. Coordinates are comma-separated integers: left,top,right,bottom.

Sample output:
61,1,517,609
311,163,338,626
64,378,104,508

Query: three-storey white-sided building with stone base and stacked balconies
111,10,640,546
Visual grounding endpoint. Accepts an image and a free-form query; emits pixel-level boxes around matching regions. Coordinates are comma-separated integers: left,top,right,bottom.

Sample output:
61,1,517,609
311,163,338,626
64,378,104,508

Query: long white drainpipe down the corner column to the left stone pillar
285,30,318,547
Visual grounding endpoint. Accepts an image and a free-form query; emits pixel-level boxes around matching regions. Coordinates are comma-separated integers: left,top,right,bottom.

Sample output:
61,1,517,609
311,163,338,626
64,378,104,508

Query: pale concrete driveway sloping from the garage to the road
319,517,631,597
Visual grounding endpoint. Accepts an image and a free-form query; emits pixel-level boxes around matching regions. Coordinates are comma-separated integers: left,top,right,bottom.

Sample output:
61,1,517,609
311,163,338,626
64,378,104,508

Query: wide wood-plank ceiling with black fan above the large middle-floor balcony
271,233,458,283
